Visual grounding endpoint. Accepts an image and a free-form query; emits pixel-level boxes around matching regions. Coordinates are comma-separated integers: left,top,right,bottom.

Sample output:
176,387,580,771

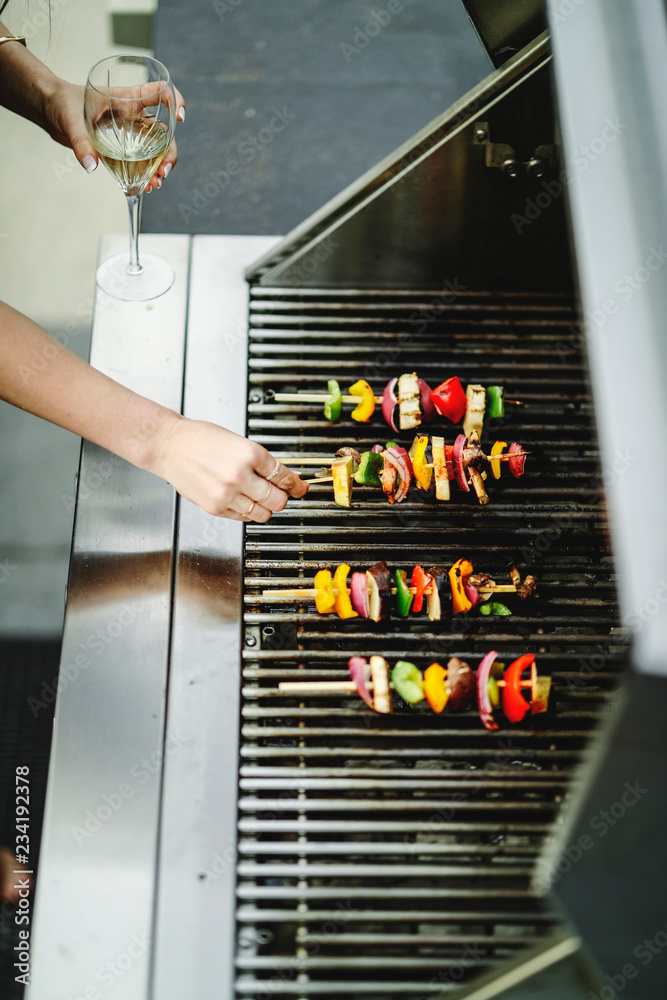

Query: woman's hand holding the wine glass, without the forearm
38,78,185,191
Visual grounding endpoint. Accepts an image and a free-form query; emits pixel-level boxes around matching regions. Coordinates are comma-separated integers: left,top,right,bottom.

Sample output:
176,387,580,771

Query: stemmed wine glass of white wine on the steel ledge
83,55,176,302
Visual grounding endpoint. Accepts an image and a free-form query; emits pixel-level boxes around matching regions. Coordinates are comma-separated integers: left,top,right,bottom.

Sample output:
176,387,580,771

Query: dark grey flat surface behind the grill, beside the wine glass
143,0,491,235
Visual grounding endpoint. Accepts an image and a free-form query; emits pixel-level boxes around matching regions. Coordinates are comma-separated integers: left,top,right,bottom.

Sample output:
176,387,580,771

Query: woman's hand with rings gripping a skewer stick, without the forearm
149,417,308,522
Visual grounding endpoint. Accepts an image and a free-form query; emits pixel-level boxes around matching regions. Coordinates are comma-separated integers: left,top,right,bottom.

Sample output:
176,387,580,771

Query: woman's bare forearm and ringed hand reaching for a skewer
0,303,308,521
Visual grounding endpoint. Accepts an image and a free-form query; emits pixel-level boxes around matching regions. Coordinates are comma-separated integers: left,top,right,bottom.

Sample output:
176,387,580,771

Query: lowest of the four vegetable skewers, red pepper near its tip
278,650,551,731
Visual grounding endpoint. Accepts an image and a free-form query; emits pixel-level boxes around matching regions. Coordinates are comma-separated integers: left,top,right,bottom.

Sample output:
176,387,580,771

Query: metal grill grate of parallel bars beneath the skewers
237,288,626,1000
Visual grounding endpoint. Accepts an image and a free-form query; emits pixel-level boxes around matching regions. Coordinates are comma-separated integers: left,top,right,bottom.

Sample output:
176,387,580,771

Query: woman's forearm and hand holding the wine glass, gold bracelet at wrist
0,21,185,190
